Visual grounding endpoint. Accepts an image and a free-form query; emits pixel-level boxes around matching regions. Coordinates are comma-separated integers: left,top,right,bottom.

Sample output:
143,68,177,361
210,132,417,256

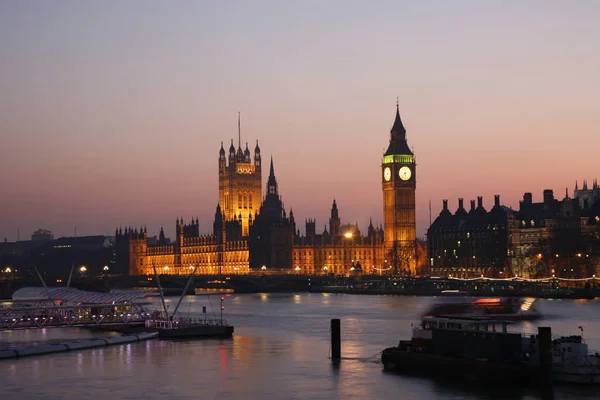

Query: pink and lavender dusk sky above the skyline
0,0,600,241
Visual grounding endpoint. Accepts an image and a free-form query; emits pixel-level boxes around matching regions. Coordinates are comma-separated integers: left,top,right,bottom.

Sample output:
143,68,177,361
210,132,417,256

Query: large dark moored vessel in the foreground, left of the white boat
381,316,539,383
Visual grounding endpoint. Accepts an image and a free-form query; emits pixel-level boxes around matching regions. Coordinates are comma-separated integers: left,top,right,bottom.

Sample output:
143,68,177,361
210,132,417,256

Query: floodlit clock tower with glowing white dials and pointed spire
381,104,417,275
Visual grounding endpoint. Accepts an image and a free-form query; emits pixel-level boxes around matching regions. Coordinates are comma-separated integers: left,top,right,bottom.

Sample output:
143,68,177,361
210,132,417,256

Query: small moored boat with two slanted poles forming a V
145,265,233,339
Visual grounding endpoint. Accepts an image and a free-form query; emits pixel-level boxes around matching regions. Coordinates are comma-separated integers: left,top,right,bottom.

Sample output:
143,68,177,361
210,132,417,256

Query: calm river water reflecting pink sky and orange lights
0,293,600,400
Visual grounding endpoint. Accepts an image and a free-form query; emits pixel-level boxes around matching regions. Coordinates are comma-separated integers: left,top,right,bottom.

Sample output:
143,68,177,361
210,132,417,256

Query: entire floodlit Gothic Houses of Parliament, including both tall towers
115,105,425,275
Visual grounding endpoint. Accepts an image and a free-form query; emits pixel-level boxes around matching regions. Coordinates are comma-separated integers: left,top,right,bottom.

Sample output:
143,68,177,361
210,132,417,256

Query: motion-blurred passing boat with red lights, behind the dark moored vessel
423,297,542,321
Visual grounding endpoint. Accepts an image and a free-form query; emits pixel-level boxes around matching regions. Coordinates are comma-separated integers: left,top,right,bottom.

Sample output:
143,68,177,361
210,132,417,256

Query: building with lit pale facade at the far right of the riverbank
509,185,600,278
